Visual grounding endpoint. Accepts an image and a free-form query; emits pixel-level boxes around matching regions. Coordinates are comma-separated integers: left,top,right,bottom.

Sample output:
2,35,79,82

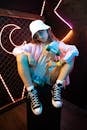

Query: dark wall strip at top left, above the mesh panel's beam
0,0,43,14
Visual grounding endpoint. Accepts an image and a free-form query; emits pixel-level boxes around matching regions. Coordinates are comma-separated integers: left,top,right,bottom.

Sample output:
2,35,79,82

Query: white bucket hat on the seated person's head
29,20,50,38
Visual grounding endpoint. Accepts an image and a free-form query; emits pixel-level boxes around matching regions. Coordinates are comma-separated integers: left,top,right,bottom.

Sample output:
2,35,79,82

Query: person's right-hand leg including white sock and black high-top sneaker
52,61,74,108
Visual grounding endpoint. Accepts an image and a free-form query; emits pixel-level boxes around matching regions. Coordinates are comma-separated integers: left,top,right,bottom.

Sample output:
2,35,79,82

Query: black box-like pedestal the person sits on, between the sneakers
27,86,61,130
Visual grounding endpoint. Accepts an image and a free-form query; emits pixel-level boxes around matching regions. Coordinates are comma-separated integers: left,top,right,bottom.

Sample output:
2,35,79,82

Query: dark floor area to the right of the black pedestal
61,100,87,130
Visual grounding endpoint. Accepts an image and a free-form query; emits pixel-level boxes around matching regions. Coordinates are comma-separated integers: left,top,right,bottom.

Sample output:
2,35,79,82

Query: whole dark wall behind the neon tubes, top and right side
0,0,87,108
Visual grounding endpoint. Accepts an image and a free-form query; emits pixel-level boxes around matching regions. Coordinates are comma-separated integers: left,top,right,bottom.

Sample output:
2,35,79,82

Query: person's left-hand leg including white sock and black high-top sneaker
17,54,42,115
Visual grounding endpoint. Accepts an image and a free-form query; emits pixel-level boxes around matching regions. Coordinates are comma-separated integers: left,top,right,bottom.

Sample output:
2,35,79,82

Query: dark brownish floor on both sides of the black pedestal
0,100,87,130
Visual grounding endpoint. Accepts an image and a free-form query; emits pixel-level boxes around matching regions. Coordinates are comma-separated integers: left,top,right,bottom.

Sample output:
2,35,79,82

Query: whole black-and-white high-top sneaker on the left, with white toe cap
27,89,42,115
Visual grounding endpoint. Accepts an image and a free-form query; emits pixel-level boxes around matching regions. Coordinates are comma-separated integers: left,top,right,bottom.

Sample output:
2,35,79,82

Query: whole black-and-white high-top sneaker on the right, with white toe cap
52,83,62,108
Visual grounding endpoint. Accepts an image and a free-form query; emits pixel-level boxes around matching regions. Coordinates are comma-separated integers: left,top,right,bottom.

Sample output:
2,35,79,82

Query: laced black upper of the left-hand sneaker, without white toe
28,89,40,109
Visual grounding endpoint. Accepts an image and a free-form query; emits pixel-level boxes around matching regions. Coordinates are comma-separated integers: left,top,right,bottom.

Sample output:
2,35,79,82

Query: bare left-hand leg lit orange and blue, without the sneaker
16,54,33,89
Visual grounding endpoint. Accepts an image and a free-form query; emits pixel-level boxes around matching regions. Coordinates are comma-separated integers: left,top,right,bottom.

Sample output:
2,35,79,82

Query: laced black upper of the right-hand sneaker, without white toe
52,84,62,101
